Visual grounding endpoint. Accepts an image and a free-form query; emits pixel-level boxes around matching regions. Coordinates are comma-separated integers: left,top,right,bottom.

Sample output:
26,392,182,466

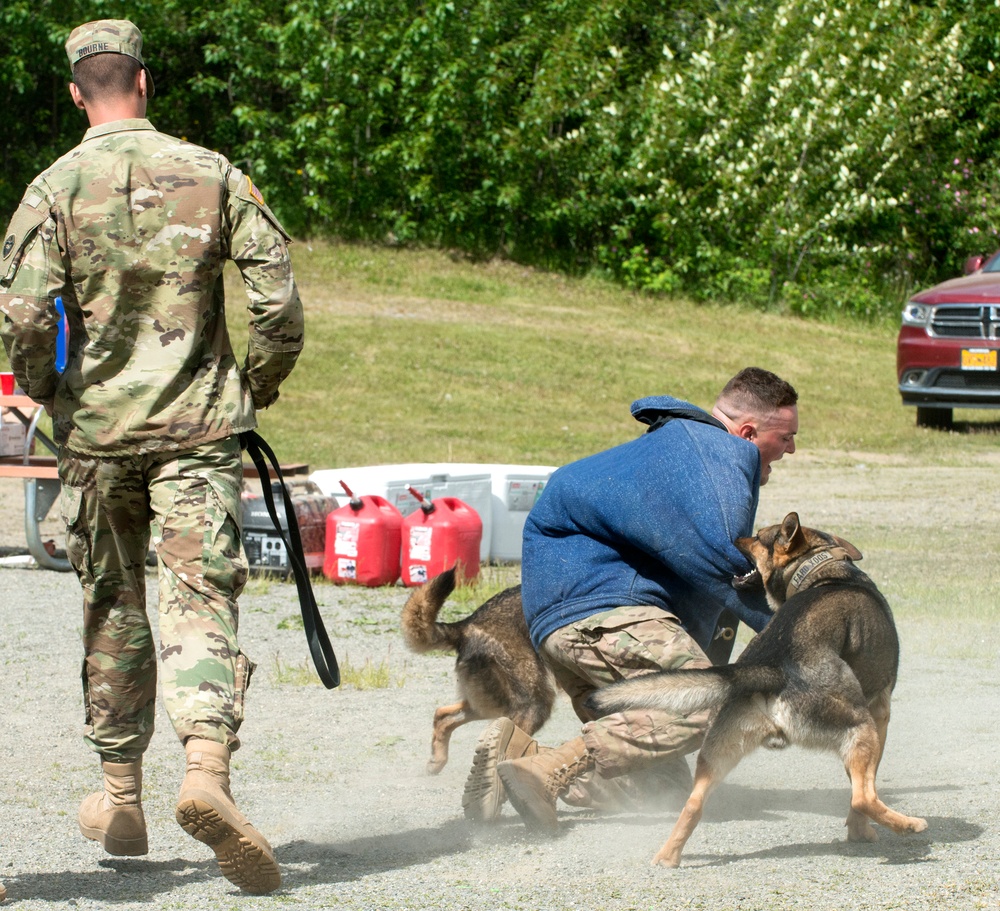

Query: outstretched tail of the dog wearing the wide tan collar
587,664,785,716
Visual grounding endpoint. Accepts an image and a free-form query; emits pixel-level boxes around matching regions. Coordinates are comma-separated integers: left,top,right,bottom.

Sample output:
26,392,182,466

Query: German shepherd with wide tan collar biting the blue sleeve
590,512,927,867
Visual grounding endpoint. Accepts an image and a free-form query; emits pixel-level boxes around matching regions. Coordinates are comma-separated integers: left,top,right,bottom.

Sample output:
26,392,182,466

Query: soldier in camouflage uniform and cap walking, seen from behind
0,20,303,893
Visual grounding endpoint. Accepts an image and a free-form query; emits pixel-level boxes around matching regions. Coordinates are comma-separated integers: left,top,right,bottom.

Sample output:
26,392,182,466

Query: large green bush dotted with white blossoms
600,0,962,311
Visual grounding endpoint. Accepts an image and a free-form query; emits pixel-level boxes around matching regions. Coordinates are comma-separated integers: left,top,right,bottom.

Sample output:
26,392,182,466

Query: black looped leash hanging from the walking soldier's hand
240,430,340,690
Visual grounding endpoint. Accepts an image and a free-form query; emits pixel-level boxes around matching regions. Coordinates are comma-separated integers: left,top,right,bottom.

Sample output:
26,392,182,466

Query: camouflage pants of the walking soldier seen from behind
59,437,253,762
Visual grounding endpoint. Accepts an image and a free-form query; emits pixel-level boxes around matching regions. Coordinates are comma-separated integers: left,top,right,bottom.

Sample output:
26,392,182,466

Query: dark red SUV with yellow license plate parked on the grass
896,251,1000,428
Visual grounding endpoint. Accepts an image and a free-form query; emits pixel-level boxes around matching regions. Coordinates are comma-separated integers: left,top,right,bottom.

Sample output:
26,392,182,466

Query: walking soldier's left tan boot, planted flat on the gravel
80,759,149,857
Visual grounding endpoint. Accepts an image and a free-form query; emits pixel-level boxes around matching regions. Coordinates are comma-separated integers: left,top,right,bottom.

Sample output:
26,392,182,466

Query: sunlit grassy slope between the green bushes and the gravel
221,242,1000,468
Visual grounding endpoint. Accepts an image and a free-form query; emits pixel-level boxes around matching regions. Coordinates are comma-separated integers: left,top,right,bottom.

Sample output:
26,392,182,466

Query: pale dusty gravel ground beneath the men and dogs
0,454,1000,911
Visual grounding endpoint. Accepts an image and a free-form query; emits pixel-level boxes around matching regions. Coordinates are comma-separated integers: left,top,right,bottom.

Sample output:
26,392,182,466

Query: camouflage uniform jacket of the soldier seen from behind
0,119,303,456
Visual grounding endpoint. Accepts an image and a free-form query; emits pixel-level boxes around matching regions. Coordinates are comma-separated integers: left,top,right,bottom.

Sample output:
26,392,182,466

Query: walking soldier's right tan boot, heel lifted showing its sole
176,740,281,895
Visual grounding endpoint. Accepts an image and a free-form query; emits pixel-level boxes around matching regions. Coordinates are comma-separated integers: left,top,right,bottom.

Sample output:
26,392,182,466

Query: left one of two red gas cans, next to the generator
323,481,403,586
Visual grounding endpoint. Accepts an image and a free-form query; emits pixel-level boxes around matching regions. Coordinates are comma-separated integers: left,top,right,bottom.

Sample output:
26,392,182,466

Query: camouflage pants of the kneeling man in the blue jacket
540,607,711,806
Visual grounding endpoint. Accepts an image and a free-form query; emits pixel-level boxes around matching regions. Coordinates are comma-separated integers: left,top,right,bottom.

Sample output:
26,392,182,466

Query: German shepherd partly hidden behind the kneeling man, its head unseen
401,567,556,775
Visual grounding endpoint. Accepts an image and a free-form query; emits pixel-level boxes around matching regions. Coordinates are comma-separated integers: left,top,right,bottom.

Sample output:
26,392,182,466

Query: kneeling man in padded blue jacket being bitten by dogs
463,367,798,831
